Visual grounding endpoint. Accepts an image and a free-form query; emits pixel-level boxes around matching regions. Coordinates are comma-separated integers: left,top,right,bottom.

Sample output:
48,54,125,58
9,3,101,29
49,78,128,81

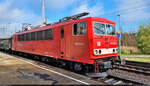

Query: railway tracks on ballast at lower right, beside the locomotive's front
105,61,150,85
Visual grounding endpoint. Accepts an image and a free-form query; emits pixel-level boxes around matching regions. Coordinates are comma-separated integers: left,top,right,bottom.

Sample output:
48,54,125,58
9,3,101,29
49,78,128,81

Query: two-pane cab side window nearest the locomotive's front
73,22,86,36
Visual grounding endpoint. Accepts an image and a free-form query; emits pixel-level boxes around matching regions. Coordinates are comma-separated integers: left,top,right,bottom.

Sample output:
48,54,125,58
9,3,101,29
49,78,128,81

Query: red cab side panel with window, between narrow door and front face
67,21,89,61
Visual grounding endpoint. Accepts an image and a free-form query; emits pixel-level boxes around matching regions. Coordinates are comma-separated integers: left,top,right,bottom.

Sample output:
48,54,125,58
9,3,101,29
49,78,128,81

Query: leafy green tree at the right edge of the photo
137,24,150,54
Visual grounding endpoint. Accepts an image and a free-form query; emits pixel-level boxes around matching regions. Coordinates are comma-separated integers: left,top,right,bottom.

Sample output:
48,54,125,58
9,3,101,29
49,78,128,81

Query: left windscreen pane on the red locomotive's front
94,22,106,35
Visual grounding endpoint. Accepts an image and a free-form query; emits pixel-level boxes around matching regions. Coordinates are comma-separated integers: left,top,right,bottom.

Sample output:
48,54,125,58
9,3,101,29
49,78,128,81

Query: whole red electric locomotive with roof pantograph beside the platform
12,13,123,76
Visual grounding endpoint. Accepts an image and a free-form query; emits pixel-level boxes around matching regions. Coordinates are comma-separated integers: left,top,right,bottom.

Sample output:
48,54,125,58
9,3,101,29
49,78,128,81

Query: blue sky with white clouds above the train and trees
0,0,150,36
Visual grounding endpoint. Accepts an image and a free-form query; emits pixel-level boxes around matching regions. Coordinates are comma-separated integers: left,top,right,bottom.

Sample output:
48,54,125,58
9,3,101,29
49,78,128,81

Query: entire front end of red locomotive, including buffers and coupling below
89,17,118,72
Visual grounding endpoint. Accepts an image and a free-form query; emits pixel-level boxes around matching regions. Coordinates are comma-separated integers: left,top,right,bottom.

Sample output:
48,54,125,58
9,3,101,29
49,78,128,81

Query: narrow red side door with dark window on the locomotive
60,27,66,58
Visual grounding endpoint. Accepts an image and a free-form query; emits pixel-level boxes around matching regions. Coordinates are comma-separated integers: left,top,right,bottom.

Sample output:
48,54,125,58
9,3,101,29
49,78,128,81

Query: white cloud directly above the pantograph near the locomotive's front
72,1,104,16
